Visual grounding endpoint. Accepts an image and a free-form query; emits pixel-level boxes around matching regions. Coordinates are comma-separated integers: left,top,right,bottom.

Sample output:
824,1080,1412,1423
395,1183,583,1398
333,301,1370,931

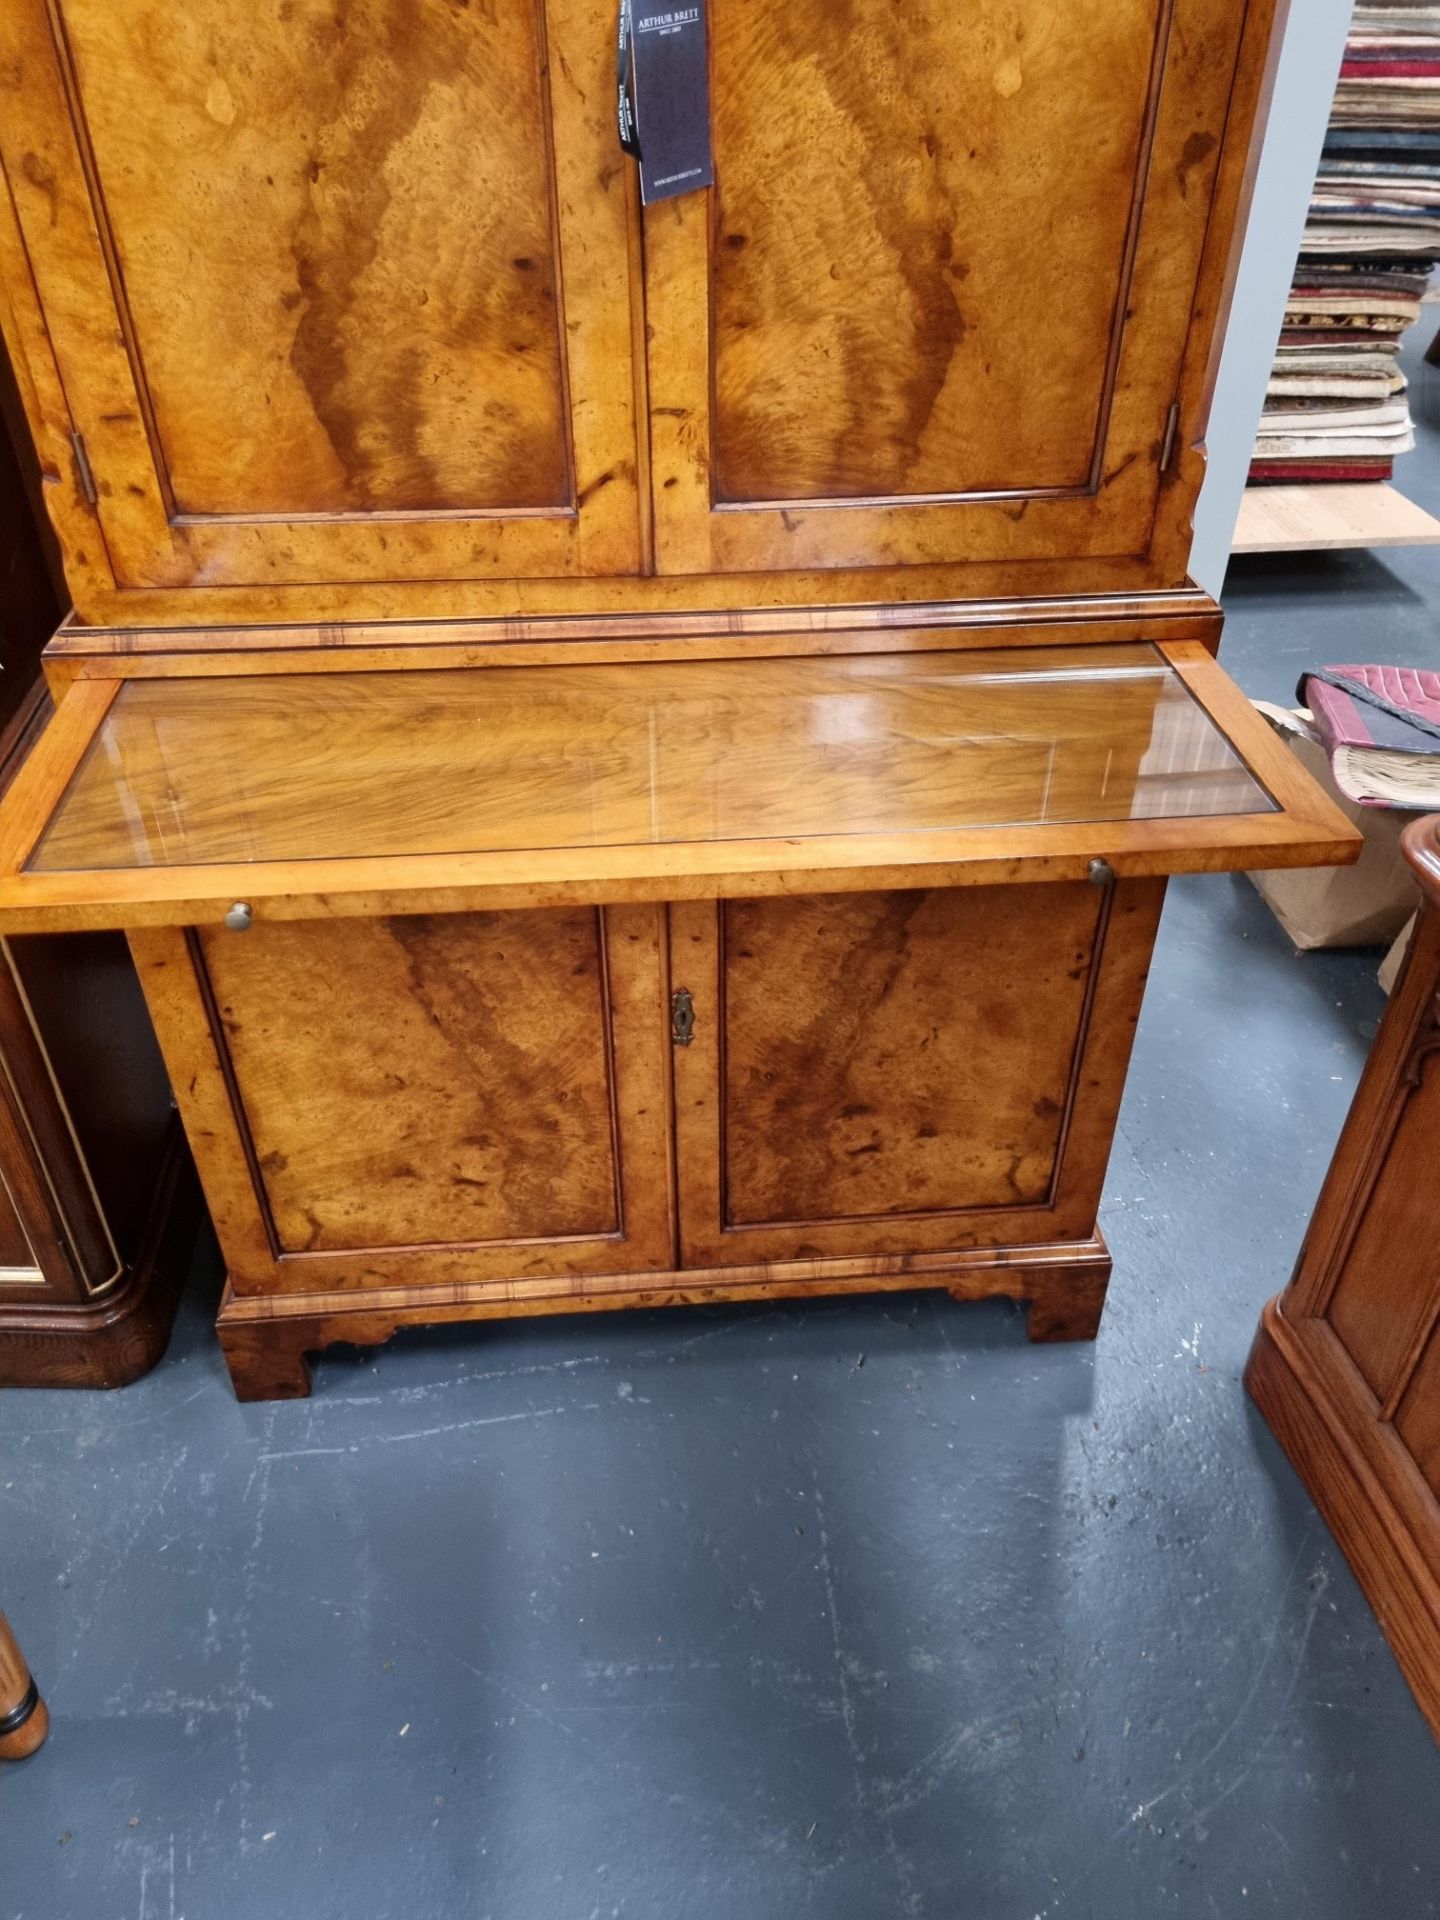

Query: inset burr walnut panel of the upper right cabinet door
710,0,1164,503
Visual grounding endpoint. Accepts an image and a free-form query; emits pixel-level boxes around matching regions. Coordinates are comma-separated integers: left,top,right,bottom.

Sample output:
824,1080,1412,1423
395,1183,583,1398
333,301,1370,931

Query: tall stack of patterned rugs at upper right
1250,0,1440,482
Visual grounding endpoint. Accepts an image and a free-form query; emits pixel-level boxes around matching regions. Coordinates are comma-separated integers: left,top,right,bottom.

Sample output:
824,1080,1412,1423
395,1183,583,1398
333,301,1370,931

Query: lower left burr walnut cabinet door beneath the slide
131,906,674,1294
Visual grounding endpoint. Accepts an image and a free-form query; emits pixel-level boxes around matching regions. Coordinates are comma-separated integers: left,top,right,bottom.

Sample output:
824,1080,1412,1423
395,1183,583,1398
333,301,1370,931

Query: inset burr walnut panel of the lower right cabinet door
716,883,1104,1229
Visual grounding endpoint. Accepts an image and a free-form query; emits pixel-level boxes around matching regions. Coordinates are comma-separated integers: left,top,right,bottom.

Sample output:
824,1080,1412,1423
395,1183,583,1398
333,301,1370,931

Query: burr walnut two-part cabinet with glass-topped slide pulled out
0,0,1357,1396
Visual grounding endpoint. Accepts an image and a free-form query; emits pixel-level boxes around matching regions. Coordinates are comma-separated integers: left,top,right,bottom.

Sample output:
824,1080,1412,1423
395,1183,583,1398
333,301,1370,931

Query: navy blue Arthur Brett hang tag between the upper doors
620,0,714,207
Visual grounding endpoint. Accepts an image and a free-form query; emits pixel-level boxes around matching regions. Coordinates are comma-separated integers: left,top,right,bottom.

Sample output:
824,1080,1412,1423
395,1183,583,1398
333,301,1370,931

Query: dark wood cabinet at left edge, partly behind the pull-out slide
0,359,194,1386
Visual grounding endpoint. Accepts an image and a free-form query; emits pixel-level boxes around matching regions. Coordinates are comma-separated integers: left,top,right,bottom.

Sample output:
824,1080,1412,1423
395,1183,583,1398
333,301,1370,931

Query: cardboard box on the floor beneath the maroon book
1250,701,1419,952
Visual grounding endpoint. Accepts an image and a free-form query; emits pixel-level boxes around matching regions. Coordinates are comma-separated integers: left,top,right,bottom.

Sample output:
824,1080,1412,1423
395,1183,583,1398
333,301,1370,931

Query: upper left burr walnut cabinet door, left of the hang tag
0,0,641,588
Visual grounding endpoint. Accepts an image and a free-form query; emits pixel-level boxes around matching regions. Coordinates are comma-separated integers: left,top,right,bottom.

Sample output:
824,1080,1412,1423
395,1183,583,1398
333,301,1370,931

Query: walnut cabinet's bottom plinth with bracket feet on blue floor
217,1235,1110,1400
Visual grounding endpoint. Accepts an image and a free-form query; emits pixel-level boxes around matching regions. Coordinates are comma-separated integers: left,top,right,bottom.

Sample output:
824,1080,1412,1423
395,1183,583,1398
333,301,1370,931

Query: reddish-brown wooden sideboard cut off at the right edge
1246,818,1440,1740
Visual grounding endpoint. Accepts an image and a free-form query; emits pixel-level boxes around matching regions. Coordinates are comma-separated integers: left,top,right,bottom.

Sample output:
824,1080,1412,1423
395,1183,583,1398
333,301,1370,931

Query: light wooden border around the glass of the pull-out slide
0,641,1359,933
